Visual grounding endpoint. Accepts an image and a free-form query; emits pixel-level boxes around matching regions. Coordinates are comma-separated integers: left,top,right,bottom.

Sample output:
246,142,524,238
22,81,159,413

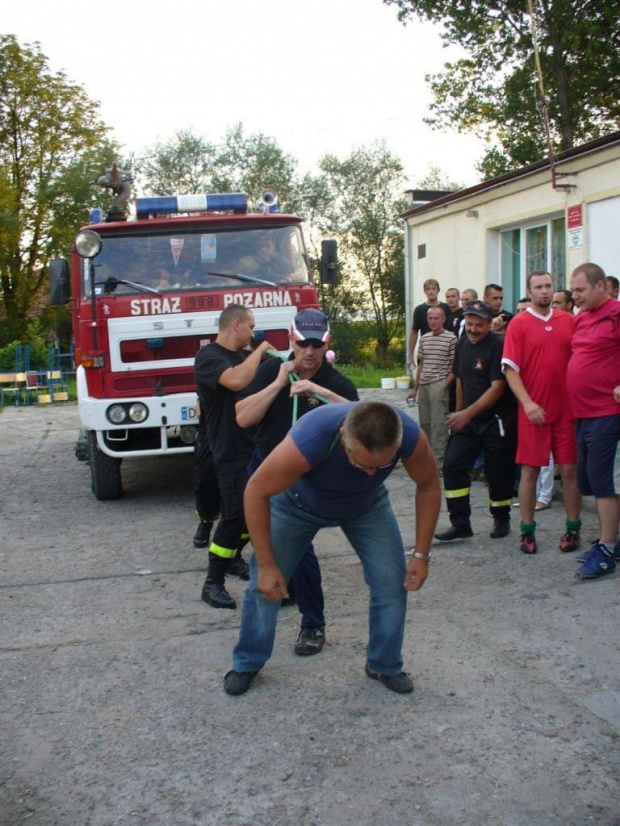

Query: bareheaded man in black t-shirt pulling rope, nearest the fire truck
194,304,272,608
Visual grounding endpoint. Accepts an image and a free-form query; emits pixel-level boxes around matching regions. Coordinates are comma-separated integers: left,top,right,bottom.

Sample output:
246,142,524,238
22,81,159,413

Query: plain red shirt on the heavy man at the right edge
567,298,620,419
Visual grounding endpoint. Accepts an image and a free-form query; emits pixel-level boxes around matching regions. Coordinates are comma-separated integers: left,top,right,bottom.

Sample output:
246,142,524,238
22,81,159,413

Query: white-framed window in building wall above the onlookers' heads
500,217,566,311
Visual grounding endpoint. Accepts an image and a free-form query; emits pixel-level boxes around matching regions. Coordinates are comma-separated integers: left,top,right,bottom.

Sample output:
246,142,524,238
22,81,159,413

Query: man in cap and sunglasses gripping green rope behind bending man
236,310,358,656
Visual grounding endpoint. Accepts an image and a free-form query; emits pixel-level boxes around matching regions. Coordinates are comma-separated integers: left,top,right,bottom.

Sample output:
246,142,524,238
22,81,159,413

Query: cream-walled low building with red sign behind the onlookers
404,132,620,323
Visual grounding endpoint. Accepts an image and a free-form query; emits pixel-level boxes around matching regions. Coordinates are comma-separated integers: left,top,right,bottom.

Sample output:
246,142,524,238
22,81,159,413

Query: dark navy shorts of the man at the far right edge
575,414,620,499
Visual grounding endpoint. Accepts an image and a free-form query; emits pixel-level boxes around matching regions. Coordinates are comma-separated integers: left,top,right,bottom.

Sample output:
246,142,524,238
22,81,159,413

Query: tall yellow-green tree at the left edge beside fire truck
0,35,115,342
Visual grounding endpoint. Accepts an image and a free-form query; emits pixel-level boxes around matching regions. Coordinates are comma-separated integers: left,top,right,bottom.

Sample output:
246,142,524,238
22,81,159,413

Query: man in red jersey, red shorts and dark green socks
502,270,581,554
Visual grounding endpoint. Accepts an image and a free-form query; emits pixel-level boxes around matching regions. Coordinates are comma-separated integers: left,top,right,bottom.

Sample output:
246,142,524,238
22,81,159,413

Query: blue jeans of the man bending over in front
233,488,407,675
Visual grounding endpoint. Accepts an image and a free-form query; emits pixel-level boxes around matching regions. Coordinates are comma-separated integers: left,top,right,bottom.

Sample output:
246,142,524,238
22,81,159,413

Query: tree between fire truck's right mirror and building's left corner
319,141,405,364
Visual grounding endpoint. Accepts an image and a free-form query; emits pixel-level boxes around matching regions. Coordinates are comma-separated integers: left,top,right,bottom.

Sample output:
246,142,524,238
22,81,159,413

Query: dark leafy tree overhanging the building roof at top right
383,0,620,177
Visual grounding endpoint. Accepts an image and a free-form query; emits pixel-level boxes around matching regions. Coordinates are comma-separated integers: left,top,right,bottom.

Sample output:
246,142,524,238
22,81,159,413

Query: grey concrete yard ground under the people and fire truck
0,390,620,826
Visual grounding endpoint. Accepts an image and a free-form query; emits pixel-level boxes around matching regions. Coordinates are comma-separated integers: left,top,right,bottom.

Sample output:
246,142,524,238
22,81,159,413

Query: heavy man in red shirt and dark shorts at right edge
566,264,620,579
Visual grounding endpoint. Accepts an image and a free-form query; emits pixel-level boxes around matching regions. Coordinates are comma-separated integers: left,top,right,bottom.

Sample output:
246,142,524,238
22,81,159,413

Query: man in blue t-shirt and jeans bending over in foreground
224,402,441,694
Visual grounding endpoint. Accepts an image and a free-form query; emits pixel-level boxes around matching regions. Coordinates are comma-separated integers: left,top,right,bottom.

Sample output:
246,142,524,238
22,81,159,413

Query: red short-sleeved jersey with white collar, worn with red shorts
502,307,575,424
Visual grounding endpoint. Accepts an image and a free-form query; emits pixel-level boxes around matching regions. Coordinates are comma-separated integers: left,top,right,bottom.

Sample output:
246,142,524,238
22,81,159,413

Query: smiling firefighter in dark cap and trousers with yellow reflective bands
435,300,517,542
